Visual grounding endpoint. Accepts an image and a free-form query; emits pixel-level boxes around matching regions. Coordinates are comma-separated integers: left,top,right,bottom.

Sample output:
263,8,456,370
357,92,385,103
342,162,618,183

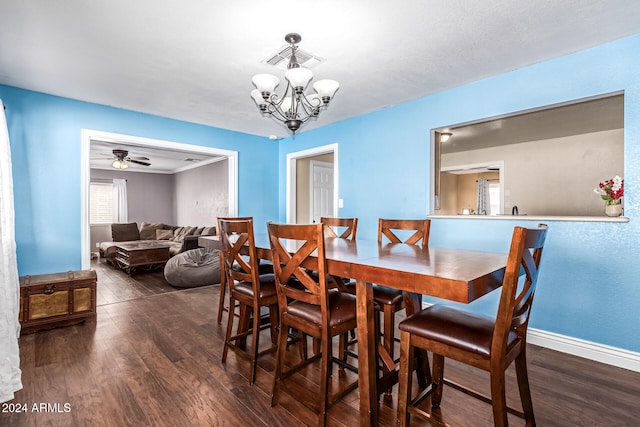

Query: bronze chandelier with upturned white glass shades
251,33,340,135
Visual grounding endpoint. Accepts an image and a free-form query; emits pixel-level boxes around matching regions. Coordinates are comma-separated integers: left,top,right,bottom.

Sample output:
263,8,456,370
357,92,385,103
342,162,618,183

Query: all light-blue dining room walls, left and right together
5,36,640,352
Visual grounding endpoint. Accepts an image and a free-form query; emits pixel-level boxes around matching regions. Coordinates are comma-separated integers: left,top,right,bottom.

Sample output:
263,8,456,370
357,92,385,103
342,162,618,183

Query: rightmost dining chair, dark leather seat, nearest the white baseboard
398,224,548,426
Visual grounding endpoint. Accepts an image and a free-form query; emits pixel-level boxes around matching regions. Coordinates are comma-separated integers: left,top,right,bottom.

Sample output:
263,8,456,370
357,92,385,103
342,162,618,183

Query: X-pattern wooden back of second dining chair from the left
267,223,328,321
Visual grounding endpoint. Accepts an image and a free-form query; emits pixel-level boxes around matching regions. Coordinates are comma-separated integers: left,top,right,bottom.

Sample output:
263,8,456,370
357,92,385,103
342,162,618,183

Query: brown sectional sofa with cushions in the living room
99,222,216,264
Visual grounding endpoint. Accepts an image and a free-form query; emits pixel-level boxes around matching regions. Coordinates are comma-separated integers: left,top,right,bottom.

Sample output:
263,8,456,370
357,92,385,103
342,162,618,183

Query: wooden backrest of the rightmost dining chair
491,224,548,355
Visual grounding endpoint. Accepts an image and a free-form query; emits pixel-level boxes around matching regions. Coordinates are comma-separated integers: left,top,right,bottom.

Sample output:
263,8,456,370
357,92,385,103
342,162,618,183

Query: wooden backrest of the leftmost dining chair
218,217,260,295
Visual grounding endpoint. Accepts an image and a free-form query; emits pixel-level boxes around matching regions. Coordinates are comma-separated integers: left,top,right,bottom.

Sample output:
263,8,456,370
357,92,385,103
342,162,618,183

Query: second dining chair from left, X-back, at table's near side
267,223,358,426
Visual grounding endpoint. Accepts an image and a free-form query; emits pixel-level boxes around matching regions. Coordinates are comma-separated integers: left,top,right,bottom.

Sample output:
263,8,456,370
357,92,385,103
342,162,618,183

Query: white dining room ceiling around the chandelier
0,0,640,169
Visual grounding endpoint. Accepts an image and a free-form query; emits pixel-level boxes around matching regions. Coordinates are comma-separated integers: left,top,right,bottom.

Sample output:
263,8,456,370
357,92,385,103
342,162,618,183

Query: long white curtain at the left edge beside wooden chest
0,100,22,402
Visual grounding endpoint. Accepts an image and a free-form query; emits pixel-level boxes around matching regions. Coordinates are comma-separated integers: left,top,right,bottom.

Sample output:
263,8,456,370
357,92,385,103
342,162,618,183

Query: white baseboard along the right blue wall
527,328,640,372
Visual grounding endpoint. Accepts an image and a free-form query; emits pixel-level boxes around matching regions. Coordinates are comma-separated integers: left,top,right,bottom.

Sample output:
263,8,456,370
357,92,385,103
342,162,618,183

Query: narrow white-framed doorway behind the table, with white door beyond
286,144,338,224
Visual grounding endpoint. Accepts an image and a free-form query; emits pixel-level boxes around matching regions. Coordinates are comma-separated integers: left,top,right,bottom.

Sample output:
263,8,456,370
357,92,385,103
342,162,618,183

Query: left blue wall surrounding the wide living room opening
0,86,278,275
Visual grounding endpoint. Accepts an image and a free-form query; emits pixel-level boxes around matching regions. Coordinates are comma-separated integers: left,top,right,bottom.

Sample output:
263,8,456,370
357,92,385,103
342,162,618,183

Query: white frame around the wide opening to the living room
80,129,238,270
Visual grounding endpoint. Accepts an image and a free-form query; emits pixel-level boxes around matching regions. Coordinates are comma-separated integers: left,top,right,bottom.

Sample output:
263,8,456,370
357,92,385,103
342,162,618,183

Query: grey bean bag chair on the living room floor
164,248,220,288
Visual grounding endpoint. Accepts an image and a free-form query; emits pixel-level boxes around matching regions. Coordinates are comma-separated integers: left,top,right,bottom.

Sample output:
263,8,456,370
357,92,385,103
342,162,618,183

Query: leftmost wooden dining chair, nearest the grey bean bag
218,217,278,384
